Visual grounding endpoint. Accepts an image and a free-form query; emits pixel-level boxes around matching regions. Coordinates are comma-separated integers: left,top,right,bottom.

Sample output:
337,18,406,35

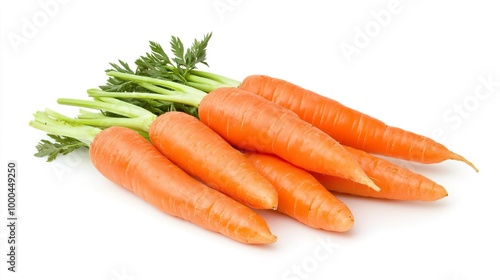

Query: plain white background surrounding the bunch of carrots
0,0,500,280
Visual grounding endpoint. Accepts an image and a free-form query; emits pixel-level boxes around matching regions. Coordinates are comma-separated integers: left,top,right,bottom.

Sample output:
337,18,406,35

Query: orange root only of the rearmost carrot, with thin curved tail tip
240,75,477,171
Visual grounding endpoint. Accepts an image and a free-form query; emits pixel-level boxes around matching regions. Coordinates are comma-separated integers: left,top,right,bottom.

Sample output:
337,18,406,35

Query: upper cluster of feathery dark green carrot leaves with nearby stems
95,33,211,116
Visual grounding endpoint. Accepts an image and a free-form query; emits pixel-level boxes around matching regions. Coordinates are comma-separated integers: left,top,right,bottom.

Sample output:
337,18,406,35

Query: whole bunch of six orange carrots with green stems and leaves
30,33,477,244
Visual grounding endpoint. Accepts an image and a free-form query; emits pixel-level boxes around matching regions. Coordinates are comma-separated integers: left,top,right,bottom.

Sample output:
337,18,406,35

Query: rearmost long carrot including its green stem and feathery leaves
150,34,478,172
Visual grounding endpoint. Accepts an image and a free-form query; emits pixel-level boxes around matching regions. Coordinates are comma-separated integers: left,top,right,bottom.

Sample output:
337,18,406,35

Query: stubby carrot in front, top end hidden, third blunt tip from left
245,152,354,232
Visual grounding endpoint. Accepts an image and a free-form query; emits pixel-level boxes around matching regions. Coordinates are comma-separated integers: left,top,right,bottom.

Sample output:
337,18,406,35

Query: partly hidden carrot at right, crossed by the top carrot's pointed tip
313,144,448,201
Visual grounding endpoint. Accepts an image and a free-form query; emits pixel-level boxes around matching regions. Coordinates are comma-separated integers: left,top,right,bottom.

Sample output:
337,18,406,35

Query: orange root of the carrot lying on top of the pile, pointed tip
198,87,378,189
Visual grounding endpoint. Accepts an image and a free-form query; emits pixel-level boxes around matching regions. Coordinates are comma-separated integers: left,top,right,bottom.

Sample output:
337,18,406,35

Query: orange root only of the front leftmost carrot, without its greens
89,127,276,244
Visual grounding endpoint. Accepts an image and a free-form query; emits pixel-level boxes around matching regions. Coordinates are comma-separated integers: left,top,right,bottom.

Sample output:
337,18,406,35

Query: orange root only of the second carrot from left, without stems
149,112,278,209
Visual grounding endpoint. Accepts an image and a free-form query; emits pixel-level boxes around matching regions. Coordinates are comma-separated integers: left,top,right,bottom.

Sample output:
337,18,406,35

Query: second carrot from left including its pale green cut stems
58,97,278,209
